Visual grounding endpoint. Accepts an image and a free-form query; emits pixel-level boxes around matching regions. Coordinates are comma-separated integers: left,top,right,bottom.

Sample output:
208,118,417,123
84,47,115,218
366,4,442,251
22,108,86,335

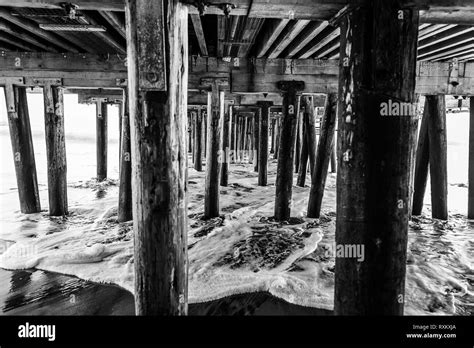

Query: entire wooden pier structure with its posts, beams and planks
0,0,474,315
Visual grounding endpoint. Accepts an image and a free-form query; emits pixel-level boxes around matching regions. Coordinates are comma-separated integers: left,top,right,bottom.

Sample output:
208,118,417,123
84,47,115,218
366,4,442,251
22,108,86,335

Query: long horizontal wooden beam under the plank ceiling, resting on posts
0,52,474,94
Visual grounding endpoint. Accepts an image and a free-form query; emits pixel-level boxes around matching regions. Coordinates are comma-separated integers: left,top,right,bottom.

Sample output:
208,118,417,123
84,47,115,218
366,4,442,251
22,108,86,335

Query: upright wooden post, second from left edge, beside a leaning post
43,84,68,216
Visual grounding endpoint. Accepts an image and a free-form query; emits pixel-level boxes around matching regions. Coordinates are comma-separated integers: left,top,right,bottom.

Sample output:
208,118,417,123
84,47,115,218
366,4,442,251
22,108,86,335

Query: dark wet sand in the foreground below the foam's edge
0,269,331,315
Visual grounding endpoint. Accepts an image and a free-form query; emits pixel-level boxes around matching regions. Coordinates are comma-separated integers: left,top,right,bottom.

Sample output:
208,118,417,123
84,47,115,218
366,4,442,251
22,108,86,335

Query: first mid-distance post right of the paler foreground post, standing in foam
204,80,224,219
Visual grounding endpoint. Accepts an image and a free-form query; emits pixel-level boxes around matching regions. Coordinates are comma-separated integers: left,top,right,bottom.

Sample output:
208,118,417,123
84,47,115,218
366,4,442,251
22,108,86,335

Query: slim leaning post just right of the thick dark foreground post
412,98,430,215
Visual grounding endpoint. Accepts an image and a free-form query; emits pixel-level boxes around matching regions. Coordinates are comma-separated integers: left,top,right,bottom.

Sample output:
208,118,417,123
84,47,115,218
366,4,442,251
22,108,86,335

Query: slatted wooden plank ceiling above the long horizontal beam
0,1,474,61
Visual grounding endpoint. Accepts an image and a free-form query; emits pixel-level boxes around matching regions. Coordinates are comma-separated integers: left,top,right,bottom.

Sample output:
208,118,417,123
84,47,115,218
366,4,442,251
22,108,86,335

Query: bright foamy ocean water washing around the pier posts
0,91,474,315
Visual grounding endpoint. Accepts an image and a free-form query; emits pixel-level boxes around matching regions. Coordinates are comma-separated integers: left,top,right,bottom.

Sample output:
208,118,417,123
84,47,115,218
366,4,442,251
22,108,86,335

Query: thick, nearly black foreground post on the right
334,0,419,315
